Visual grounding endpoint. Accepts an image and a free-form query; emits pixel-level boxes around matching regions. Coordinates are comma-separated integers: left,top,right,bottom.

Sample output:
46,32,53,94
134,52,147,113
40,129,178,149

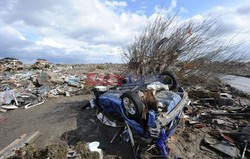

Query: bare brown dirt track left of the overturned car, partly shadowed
0,95,132,158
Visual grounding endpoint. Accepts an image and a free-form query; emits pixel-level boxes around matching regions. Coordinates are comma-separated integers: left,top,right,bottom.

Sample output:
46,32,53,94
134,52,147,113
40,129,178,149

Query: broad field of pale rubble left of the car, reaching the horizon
0,58,125,112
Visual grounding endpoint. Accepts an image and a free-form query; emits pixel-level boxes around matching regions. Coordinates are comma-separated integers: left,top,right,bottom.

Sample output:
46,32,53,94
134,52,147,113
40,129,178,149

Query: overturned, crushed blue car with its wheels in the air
90,72,190,158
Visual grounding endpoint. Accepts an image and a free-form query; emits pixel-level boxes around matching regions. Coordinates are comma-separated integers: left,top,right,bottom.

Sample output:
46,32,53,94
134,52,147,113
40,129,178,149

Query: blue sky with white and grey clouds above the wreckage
0,0,250,63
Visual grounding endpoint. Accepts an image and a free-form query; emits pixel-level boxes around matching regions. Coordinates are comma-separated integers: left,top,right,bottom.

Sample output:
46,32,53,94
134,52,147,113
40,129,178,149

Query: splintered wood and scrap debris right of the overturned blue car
172,86,250,158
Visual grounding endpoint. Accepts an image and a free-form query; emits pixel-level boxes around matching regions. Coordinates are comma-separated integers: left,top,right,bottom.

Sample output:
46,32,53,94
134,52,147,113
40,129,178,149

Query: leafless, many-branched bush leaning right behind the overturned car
123,12,246,75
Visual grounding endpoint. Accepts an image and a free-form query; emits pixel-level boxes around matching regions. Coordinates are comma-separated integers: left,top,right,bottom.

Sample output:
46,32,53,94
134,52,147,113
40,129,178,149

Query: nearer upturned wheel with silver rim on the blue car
121,91,143,120
